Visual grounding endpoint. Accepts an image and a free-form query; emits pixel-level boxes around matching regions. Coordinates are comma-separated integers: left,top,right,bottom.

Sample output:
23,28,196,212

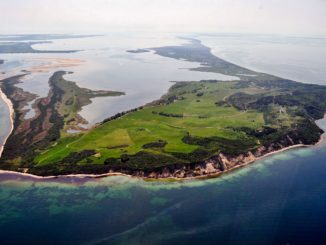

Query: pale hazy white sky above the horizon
0,0,326,36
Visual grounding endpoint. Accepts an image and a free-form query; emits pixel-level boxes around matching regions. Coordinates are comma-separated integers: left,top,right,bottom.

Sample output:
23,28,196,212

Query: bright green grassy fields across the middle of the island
35,82,264,166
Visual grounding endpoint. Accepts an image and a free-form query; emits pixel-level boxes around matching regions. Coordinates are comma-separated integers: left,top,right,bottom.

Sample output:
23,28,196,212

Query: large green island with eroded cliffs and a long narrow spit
0,39,326,178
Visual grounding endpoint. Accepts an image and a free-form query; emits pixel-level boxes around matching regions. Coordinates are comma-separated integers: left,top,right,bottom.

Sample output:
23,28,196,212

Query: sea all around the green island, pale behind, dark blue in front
0,33,326,244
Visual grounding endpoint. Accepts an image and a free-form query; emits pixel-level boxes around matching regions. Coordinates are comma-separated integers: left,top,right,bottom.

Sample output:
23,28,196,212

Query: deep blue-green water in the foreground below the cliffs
0,121,326,244
